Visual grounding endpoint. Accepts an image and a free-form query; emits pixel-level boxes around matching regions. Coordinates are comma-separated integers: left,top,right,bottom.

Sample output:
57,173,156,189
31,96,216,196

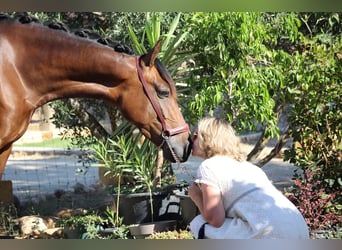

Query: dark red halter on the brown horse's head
136,56,190,162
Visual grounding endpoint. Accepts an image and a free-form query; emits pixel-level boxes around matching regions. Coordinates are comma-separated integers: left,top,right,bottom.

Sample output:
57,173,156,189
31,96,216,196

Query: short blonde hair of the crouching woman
198,117,246,162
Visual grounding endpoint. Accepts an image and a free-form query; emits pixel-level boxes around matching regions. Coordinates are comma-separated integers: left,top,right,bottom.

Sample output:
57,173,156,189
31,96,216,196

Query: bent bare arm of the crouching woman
189,183,225,227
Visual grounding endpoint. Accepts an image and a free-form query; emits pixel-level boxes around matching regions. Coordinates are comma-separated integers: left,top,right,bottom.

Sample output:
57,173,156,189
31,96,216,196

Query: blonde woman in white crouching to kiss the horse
189,117,309,239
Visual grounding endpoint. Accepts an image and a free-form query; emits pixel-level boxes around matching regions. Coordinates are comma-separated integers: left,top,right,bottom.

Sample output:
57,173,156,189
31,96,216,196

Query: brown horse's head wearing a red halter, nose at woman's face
119,40,192,162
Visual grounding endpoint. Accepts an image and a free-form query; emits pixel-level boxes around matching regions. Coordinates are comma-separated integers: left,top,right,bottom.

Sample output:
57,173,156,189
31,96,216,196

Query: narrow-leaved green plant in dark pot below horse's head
94,122,174,228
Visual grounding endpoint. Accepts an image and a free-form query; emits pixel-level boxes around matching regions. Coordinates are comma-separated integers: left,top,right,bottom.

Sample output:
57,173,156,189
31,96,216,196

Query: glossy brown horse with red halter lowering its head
0,17,191,180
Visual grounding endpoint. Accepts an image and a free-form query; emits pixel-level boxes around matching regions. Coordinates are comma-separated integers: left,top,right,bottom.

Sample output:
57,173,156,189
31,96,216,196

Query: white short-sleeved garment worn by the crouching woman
190,156,309,239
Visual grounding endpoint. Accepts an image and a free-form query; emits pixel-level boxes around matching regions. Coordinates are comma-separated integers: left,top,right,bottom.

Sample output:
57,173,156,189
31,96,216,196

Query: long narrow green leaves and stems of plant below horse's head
93,121,172,227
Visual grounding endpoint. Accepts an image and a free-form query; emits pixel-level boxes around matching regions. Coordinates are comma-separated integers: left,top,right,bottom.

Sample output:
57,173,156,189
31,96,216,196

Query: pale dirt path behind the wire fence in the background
3,144,297,217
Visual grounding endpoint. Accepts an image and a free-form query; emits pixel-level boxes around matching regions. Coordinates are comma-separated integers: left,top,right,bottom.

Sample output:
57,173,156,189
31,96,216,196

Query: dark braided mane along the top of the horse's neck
0,12,133,55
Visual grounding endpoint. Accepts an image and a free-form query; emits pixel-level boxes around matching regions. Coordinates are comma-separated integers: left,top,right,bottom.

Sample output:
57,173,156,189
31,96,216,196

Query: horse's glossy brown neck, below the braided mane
8,23,135,107
